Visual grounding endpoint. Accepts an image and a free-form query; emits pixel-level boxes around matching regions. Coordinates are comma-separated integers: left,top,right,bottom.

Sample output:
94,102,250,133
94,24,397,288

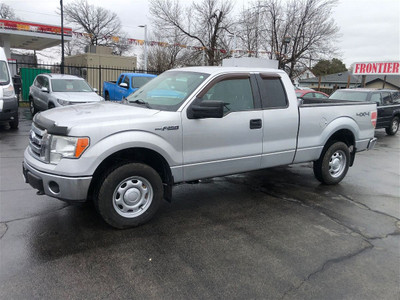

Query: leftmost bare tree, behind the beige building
64,0,129,55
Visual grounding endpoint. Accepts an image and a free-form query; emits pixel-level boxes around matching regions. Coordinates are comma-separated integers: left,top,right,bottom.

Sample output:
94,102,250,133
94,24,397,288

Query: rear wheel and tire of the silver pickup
313,141,350,185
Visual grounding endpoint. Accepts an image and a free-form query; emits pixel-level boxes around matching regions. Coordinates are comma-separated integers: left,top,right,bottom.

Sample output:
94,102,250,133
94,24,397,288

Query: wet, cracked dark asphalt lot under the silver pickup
0,108,400,299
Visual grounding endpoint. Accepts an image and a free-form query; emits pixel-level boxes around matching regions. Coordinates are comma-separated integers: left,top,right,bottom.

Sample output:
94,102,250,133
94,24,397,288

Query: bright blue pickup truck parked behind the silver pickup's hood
103,73,156,100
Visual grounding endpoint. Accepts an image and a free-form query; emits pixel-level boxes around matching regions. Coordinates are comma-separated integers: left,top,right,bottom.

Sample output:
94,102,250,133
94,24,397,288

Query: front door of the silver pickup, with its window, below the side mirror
182,73,263,181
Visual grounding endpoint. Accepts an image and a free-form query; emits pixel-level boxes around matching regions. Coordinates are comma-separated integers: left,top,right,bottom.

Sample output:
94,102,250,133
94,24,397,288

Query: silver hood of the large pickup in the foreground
34,101,159,133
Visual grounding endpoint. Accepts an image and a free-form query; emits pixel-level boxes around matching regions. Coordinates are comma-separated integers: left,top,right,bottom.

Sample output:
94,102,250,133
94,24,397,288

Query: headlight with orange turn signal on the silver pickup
49,135,89,164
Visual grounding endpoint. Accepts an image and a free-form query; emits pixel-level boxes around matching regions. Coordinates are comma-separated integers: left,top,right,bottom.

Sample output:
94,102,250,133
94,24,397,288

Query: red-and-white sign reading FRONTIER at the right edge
353,61,400,75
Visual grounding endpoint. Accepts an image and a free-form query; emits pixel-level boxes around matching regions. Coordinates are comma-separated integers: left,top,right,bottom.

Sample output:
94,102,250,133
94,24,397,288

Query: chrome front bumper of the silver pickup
22,161,92,202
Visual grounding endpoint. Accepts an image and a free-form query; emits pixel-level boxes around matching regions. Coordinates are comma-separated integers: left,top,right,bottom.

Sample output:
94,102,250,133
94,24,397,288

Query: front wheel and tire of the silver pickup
94,163,163,229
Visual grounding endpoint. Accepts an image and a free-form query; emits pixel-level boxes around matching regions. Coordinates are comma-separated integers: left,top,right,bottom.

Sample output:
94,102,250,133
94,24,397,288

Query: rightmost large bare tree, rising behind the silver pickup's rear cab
260,0,338,78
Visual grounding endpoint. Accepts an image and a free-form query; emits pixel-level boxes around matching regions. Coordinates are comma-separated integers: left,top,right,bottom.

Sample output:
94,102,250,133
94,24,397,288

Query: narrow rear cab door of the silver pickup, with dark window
256,73,299,168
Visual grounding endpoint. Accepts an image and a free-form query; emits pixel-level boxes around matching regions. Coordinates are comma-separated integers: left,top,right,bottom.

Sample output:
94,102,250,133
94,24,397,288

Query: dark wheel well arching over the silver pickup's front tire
88,148,174,201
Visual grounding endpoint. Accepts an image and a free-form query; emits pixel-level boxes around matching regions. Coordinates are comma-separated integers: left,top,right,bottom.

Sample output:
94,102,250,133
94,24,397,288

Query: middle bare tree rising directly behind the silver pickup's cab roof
150,0,233,65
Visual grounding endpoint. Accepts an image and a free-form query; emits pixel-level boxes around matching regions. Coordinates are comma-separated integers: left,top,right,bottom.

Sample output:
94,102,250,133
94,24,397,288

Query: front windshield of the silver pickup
127,71,209,111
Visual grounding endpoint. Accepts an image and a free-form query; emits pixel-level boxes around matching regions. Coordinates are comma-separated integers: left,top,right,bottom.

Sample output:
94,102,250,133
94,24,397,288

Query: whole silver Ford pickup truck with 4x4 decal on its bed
23,67,376,228
